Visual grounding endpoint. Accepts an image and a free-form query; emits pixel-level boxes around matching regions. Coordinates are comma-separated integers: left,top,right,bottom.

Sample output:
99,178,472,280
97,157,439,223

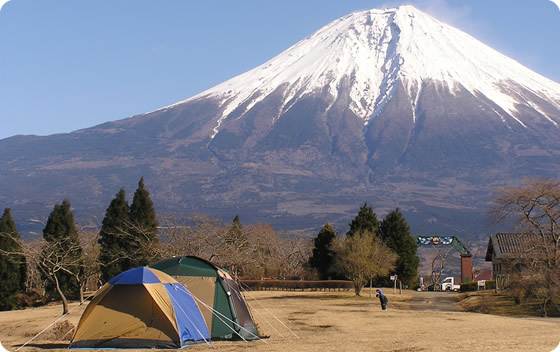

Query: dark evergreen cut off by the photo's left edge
0,208,27,309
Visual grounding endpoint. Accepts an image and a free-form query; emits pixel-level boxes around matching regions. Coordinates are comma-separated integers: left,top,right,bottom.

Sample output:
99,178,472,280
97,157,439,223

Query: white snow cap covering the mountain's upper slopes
168,5,560,138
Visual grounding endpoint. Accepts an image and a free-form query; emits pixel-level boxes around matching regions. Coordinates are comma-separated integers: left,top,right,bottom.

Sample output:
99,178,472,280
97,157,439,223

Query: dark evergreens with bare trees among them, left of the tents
0,178,158,313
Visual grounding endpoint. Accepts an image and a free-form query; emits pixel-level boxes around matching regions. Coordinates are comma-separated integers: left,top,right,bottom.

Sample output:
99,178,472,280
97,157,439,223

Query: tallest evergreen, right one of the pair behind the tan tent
128,177,158,270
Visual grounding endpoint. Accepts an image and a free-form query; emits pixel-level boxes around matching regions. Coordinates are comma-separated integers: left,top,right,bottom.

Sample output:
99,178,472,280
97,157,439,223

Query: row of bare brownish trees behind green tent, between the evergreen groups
159,216,311,278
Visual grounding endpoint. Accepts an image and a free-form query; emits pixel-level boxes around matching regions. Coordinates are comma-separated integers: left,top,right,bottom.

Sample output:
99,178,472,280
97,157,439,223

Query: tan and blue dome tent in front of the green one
70,267,210,348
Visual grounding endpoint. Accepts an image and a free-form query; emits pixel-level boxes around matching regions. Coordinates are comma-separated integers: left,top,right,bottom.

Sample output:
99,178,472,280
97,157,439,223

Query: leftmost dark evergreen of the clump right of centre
309,222,337,280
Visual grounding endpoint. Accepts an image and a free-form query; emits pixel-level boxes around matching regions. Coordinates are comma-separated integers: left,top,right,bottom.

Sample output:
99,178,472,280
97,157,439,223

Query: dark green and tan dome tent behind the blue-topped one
150,256,259,340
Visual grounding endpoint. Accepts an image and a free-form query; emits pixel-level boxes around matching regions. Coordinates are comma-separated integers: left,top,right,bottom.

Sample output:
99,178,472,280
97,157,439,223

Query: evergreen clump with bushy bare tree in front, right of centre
309,203,419,296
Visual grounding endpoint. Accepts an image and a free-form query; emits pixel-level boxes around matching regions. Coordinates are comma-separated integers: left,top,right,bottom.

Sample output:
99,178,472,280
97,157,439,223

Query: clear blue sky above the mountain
0,0,560,139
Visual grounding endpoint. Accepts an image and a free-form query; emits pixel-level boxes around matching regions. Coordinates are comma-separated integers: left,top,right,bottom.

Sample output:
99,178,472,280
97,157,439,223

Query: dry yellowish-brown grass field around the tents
0,289,560,352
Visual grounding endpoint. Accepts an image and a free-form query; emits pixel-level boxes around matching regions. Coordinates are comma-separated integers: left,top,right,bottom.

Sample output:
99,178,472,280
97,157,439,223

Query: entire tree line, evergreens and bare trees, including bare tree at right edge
0,178,560,314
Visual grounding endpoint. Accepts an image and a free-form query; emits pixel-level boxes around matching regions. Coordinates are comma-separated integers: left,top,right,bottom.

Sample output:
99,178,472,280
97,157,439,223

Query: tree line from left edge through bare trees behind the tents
0,178,311,313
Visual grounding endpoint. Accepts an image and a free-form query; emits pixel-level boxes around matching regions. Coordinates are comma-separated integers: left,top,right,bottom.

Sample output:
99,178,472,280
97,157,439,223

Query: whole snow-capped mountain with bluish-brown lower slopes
0,6,560,234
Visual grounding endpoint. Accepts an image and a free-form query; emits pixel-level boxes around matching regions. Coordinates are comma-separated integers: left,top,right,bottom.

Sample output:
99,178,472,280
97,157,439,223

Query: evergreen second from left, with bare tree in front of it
43,200,82,301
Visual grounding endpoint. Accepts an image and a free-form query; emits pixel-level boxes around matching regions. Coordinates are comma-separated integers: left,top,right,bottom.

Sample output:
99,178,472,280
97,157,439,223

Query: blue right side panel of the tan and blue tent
164,283,210,344
